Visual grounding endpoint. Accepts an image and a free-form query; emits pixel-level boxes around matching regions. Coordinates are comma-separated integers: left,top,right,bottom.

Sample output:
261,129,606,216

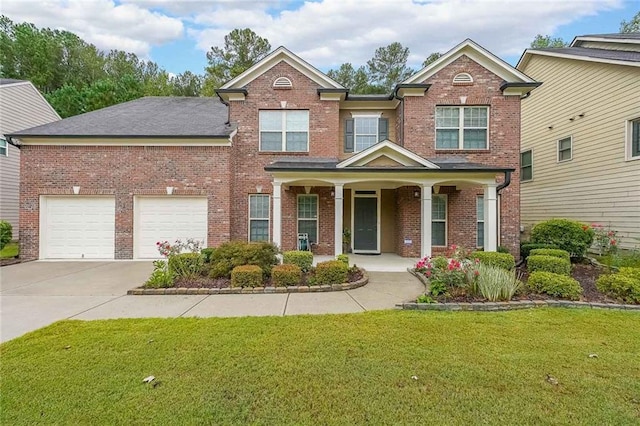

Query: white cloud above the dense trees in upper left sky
2,0,184,57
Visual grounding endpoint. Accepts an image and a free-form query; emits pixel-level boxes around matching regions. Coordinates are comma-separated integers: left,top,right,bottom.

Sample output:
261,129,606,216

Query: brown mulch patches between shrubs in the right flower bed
434,261,618,303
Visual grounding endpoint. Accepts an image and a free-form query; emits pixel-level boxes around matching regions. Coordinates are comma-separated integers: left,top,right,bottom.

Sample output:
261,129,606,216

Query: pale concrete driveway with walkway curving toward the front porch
0,261,424,342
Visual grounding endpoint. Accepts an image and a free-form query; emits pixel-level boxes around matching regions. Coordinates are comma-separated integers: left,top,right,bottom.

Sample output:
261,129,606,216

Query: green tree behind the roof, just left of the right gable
367,42,413,93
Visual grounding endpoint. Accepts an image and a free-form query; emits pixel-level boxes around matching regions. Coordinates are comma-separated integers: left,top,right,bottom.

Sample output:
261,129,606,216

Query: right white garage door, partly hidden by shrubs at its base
134,196,207,259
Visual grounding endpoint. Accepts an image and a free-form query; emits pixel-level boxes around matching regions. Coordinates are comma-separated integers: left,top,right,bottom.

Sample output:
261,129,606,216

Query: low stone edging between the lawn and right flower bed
396,300,640,312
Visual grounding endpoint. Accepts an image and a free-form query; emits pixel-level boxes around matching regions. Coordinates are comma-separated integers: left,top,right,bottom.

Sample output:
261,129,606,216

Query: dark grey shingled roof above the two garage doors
11,96,234,138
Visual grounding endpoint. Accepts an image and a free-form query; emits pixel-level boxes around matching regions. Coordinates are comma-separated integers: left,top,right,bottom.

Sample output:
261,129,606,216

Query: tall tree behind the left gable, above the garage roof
205,28,271,87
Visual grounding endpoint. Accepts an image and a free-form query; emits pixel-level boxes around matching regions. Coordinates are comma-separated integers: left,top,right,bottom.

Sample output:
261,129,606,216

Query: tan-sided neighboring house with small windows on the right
517,33,640,248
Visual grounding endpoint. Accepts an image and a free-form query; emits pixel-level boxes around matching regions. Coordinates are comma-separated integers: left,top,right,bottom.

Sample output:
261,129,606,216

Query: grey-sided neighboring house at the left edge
0,78,60,239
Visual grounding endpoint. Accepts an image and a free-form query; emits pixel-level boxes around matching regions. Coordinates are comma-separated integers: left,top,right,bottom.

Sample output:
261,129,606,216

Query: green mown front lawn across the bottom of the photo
0,309,640,425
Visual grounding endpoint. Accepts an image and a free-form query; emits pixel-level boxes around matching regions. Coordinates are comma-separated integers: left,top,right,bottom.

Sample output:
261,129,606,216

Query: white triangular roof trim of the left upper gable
220,46,344,90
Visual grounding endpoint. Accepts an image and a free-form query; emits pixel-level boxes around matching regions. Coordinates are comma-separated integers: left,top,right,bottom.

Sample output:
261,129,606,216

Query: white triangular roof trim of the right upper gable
402,38,536,84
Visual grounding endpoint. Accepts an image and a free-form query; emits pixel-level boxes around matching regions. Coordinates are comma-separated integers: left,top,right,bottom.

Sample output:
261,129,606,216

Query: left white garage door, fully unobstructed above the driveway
40,196,116,259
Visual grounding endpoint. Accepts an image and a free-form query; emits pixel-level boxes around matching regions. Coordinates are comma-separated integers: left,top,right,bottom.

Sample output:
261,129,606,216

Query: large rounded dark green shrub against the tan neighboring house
531,219,595,258
